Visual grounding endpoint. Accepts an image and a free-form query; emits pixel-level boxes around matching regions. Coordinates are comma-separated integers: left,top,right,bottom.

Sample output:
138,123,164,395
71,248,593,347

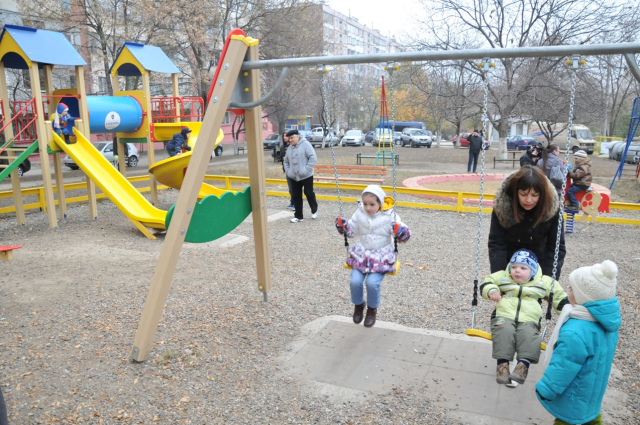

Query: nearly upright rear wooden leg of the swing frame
243,45,272,294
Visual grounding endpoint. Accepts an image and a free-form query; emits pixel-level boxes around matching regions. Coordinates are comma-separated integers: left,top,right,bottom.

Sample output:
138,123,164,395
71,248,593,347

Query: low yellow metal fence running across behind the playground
0,174,640,226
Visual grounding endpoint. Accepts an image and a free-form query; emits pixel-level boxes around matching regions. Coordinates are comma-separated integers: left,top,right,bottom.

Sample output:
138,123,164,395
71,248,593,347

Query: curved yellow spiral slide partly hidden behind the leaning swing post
149,122,226,199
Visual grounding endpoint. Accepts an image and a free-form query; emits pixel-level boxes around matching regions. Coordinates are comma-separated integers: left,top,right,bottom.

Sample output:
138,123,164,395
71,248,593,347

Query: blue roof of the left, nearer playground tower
0,25,87,69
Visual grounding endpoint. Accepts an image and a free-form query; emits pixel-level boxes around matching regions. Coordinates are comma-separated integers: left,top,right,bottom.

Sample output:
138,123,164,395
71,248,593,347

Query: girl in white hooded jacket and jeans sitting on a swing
335,185,411,328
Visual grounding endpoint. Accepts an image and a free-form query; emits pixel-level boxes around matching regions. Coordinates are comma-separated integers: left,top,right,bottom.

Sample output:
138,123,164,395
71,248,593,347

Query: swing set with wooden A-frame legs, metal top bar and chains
130,30,640,361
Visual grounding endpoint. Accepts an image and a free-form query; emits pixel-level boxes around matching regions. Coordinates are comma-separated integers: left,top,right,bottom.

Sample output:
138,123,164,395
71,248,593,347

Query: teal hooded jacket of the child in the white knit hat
536,298,620,424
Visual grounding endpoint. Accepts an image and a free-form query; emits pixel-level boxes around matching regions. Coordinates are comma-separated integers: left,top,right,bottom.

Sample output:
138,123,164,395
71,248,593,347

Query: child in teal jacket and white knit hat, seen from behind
536,260,620,425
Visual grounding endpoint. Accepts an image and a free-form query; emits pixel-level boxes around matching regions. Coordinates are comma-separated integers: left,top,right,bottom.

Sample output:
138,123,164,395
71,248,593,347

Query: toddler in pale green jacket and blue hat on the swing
480,249,569,384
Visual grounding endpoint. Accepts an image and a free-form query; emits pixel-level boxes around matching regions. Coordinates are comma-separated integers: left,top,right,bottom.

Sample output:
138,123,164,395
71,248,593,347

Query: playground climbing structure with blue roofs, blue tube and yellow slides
0,25,229,239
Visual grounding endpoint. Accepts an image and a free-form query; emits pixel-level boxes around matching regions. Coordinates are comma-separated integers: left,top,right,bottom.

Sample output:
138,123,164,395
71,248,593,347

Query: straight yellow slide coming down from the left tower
53,127,167,229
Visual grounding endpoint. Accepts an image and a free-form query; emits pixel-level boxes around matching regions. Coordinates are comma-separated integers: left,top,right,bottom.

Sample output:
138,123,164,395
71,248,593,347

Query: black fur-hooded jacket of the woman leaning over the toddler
489,174,567,279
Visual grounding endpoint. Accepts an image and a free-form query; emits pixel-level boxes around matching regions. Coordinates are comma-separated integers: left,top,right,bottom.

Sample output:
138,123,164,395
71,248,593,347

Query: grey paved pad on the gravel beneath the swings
282,316,619,425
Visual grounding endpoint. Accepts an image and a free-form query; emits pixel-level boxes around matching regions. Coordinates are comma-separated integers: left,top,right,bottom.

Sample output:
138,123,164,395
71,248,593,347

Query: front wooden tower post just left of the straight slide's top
29,62,58,229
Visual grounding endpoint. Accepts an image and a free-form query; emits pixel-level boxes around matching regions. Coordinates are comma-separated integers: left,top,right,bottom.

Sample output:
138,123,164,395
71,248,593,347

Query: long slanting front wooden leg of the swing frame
131,39,247,362
